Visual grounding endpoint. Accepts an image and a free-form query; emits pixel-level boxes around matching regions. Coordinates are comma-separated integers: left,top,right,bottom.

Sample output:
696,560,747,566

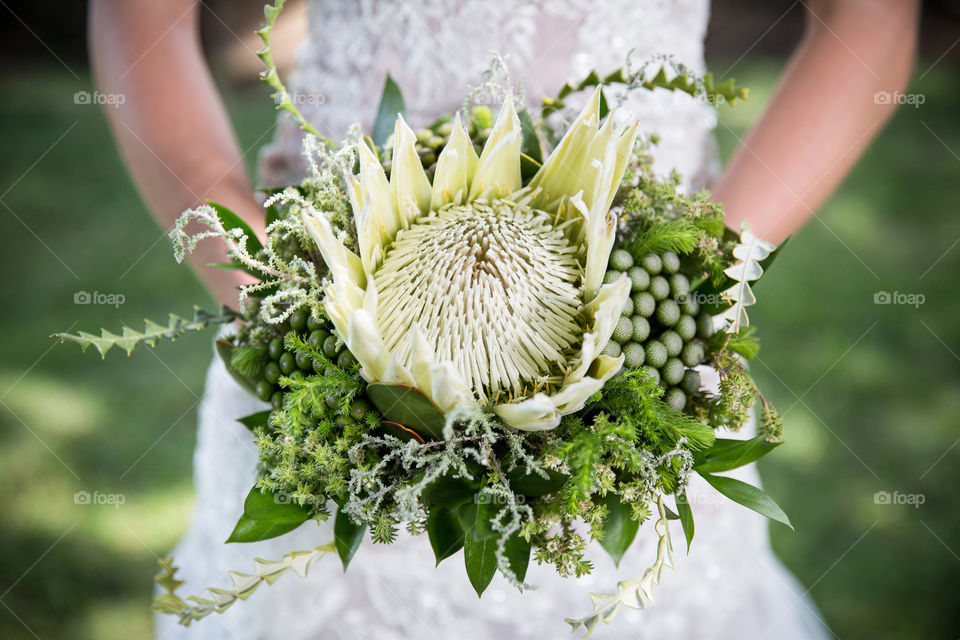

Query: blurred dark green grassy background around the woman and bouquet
0,0,960,640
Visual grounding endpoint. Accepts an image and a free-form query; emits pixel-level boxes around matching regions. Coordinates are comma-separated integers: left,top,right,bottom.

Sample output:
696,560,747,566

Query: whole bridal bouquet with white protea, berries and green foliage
60,3,789,631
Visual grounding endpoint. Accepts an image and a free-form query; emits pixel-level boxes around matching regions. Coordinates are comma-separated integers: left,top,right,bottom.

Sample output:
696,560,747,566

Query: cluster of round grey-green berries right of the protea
604,249,713,411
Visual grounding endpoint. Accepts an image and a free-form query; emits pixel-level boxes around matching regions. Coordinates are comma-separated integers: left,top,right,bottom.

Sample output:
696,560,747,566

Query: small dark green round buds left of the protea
256,309,354,409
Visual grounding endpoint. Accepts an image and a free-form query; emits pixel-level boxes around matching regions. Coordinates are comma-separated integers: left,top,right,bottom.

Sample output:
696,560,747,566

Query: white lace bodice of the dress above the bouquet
260,0,715,191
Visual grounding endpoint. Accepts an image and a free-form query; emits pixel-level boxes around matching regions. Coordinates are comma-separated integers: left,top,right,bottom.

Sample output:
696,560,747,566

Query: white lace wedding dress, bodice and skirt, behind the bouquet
157,0,827,640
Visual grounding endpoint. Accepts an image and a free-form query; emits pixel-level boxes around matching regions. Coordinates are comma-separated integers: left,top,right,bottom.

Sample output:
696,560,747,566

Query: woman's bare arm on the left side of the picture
89,0,263,306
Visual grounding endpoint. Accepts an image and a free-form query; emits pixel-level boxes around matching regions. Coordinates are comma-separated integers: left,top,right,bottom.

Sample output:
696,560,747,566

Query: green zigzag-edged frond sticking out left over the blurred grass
51,307,239,358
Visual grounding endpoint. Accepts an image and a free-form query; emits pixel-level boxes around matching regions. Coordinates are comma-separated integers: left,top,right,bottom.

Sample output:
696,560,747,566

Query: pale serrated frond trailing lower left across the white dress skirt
152,540,336,627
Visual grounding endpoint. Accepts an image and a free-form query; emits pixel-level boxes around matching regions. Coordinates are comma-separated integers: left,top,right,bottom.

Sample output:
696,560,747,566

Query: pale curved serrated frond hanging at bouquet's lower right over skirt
567,494,674,636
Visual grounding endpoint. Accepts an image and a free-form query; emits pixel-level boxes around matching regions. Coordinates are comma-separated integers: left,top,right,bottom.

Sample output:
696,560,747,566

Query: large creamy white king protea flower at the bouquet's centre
303,90,637,431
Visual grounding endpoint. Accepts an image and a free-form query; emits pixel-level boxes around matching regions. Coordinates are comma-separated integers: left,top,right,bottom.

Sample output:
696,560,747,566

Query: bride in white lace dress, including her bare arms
91,0,918,640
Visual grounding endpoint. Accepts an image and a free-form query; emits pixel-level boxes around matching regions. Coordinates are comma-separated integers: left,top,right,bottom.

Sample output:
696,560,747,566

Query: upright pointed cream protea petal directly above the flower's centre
469,94,523,200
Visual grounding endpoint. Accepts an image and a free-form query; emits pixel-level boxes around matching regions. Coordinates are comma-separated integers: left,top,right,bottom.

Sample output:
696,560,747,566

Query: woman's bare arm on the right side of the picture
713,0,919,242
